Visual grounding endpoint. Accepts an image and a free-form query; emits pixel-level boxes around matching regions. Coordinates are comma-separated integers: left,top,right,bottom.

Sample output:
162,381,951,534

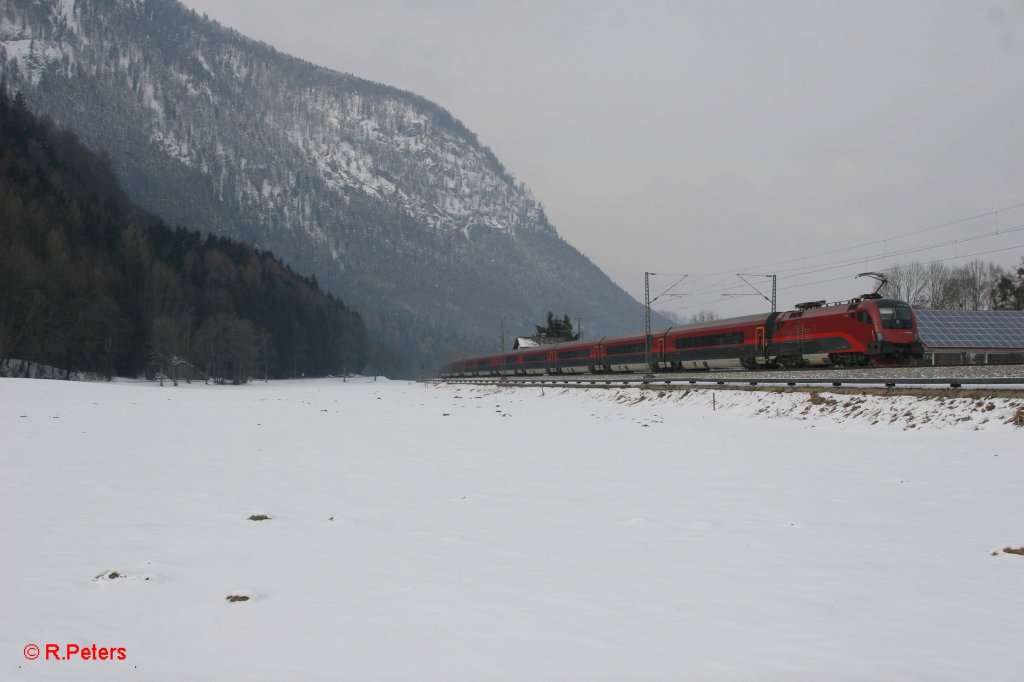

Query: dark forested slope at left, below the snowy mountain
0,83,367,383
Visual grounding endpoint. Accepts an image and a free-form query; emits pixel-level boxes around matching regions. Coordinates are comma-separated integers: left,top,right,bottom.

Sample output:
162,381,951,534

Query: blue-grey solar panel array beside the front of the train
913,308,1024,350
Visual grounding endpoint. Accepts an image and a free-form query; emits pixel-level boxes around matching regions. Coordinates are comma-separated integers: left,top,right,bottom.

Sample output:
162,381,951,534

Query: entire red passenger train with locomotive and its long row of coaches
442,294,924,377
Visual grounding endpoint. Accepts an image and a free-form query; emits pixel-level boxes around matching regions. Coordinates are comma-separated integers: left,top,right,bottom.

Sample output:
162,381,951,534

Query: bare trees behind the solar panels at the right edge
882,259,1024,310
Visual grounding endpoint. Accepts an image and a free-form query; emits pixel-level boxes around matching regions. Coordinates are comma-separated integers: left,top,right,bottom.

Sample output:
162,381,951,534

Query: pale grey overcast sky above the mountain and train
185,0,1024,314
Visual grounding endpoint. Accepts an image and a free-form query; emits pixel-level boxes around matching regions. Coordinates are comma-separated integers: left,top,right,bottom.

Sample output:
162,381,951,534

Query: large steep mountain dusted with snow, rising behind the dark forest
0,0,659,374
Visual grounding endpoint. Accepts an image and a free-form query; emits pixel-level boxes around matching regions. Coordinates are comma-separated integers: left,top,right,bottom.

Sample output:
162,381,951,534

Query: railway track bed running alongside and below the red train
431,365,1024,392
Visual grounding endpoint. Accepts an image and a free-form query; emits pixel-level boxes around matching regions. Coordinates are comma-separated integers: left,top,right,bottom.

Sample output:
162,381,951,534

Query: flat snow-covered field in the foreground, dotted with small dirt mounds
0,379,1024,682
